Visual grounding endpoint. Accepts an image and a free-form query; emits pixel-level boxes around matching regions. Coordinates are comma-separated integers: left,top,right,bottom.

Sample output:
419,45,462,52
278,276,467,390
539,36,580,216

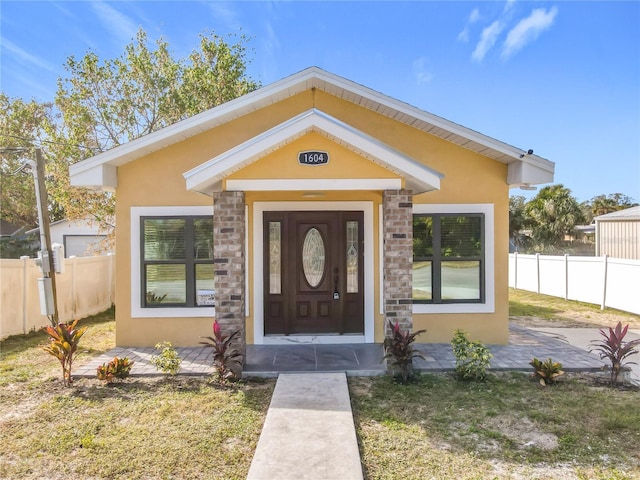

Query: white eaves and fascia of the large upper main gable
69,67,554,190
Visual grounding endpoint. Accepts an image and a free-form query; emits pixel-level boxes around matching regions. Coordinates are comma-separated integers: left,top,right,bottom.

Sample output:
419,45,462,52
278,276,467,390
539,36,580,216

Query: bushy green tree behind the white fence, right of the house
525,184,584,249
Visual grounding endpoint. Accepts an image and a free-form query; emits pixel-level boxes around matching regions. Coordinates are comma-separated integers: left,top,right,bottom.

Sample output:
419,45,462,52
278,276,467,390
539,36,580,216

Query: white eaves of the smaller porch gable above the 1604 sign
183,109,442,194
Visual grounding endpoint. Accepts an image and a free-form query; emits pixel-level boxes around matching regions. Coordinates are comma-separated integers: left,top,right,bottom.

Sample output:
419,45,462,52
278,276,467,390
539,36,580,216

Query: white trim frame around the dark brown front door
253,202,375,345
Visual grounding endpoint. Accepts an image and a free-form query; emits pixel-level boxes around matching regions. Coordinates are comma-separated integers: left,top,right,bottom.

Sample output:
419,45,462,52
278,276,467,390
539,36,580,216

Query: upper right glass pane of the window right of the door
440,216,482,258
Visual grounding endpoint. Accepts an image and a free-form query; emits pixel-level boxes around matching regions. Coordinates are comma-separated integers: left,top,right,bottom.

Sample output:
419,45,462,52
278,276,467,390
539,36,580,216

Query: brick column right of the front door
382,190,413,335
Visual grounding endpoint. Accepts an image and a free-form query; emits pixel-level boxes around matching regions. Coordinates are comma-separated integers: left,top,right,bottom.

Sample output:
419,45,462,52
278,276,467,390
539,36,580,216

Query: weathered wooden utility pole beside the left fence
29,148,62,327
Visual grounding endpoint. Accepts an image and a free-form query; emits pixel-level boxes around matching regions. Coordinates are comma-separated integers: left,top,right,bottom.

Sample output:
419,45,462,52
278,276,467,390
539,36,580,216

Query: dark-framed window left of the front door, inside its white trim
140,215,214,308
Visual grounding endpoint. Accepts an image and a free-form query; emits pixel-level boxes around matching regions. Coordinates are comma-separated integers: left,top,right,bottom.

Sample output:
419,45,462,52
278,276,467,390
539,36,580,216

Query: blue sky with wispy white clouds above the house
0,0,640,202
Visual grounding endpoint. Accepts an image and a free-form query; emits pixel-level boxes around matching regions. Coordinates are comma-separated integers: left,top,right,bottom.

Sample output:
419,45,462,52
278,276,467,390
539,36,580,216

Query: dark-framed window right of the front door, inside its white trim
413,212,486,304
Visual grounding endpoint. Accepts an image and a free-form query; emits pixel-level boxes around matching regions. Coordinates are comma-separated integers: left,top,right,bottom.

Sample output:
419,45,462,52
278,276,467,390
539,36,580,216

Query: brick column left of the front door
213,192,247,374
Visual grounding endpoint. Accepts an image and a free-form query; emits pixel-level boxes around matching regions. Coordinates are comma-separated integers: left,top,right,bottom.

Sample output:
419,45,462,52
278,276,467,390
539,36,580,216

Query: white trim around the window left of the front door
130,206,216,318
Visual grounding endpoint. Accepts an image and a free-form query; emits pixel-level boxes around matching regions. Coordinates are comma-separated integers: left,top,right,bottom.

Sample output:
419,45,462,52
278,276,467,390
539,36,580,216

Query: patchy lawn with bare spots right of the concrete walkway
349,373,640,479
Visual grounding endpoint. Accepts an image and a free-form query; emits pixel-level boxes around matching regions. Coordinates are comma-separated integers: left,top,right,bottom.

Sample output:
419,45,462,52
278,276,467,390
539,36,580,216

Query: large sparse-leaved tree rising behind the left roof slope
0,30,259,234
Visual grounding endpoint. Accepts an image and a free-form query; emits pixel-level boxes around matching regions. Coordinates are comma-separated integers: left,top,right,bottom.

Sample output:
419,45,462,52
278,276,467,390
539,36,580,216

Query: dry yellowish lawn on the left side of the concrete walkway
0,311,274,479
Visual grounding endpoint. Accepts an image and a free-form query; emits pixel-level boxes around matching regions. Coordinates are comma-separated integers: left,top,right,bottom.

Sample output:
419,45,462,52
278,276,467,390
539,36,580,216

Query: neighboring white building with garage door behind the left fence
27,220,112,258
